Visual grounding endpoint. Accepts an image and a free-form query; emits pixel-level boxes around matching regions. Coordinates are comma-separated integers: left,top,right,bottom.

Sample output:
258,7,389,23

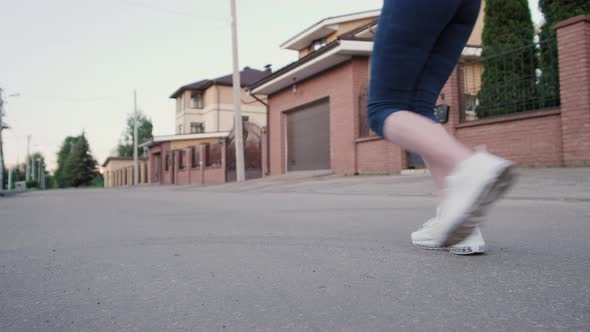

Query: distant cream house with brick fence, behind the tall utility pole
140,67,271,185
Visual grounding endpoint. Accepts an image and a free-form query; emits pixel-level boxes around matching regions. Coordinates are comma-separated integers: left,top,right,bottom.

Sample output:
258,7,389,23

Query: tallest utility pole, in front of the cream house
230,0,246,182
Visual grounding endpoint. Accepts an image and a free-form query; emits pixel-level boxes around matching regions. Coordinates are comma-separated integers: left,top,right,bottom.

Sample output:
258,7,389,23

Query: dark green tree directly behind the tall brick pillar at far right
539,0,590,107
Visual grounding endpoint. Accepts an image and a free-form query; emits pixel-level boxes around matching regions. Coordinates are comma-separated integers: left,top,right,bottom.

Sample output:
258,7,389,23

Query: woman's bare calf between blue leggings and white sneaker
383,111,473,184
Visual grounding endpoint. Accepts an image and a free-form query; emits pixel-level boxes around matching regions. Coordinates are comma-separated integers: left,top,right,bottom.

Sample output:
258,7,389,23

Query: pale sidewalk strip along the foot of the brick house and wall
185,168,590,201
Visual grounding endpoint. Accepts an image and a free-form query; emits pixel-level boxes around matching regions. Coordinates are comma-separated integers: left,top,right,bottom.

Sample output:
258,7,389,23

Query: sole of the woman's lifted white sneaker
443,164,516,248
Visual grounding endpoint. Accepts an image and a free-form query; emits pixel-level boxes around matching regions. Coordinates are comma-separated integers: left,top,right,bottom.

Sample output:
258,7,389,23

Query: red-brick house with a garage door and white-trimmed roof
250,9,483,175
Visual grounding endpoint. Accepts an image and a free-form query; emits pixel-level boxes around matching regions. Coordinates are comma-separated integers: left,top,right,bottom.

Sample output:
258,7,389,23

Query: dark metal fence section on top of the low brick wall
459,39,560,121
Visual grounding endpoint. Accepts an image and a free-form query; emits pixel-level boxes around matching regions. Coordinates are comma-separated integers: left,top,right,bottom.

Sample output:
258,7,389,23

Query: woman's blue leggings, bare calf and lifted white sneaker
368,0,513,248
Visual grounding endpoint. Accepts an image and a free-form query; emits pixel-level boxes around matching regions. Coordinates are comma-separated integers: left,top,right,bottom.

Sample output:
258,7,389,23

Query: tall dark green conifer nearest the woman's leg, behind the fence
477,0,536,118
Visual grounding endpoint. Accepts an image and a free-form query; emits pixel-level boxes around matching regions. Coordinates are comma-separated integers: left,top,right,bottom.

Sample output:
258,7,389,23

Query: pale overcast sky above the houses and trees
0,0,541,170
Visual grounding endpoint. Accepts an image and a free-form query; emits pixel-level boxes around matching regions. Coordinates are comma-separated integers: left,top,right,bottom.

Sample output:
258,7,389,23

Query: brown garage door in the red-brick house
287,101,330,172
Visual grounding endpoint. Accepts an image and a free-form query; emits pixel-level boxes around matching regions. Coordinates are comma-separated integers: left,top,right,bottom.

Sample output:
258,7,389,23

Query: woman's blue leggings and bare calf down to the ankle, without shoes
369,0,480,196
